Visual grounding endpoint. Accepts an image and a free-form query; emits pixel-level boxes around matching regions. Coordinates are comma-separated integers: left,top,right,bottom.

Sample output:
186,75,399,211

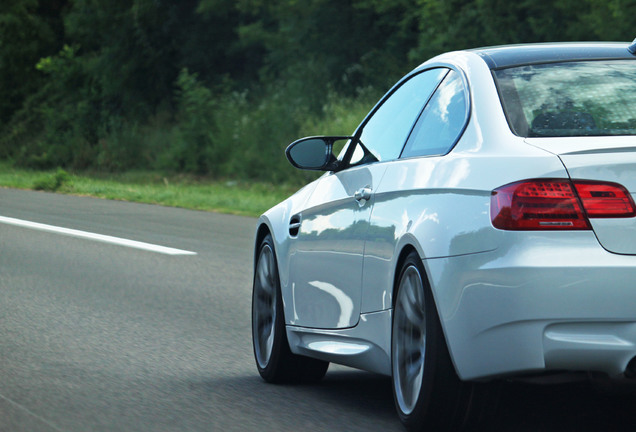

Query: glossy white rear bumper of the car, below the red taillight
423,231,636,379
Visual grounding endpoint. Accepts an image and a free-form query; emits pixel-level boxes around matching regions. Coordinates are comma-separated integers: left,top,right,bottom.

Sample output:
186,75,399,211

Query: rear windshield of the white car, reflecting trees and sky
494,60,636,137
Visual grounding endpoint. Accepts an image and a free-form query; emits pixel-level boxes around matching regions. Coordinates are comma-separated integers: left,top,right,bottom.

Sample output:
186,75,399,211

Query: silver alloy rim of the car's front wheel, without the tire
252,244,277,369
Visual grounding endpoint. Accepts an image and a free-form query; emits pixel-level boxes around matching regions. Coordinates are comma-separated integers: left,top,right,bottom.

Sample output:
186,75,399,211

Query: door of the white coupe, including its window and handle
285,68,448,329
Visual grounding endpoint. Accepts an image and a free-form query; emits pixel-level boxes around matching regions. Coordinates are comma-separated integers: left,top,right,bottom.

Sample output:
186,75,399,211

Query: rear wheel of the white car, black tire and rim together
391,252,473,431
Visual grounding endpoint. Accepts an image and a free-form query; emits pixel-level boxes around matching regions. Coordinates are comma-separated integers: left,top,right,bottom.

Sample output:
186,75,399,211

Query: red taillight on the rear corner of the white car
490,179,636,230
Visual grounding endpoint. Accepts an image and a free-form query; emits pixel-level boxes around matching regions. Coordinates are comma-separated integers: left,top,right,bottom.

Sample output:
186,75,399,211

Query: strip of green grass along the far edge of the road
0,161,298,216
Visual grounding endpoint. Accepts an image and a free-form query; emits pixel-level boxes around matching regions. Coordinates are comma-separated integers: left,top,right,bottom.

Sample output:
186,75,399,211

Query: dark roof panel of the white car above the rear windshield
469,42,636,69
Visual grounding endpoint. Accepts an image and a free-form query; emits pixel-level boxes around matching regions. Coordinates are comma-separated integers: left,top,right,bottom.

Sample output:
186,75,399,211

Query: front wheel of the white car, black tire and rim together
252,234,329,383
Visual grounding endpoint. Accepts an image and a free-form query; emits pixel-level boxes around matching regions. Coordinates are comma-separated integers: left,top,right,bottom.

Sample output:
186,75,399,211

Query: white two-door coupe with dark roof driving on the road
252,39,636,430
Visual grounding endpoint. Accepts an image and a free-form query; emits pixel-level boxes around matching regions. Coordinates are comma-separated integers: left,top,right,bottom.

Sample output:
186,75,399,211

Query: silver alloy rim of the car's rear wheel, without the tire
391,265,426,415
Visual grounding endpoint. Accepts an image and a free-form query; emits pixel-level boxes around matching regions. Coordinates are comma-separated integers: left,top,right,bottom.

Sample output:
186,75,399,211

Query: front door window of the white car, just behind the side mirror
351,68,448,165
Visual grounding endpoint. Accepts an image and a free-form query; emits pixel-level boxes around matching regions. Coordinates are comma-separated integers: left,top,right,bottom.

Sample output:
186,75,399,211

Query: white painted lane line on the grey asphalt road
0,216,197,255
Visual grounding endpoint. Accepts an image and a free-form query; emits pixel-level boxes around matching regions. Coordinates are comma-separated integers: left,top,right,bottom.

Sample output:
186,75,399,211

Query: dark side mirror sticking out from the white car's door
285,136,351,171
